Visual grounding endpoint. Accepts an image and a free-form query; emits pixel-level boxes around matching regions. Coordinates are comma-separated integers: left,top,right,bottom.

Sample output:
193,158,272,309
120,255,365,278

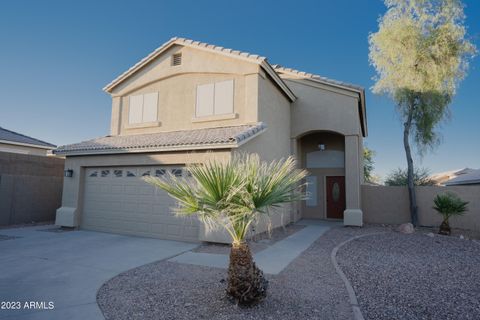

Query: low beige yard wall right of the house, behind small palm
362,185,480,232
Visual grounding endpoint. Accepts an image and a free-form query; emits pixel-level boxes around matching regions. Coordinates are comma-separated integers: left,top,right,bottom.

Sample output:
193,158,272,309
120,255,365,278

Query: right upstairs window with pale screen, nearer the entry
195,80,233,117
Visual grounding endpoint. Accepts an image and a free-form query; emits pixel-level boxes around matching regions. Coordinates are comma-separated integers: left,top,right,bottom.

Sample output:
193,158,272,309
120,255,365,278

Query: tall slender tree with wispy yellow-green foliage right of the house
369,0,476,225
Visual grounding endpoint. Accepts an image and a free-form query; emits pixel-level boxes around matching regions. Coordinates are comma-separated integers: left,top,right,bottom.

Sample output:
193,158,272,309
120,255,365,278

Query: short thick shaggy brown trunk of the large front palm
227,242,268,306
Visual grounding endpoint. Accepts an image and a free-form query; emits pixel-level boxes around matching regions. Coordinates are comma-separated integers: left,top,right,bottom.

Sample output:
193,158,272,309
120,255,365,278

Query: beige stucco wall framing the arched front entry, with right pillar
282,74,363,225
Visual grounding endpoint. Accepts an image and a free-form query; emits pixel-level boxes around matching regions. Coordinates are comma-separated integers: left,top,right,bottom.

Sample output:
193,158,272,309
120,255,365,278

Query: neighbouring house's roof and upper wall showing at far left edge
0,127,56,156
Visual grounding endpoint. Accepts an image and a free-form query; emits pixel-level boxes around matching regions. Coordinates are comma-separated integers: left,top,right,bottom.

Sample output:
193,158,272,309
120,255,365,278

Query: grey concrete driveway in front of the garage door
0,225,196,320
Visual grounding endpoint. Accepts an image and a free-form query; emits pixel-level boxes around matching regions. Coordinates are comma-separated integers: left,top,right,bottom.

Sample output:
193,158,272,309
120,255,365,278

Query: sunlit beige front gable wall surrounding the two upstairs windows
111,46,260,135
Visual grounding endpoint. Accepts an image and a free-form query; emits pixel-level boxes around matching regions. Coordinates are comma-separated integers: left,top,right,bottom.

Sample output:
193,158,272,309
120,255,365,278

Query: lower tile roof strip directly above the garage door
54,122,266,154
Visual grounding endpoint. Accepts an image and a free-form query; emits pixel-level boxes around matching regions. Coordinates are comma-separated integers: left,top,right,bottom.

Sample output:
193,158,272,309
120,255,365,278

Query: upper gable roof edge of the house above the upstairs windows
103,37,296,101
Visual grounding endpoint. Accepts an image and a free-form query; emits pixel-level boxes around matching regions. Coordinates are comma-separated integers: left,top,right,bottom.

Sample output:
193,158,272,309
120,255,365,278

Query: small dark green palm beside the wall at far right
433,192,468,235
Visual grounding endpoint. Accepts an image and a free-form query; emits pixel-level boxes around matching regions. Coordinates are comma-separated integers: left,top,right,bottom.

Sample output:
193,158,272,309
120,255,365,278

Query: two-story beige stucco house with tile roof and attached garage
55,38,367,241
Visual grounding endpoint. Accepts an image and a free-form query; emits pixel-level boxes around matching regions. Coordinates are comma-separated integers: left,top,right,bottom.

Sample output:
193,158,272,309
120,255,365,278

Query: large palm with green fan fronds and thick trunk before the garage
145,154,307,305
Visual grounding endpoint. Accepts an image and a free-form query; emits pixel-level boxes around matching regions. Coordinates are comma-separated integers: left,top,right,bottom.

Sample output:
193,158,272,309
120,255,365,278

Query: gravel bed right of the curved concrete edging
337,228,480,320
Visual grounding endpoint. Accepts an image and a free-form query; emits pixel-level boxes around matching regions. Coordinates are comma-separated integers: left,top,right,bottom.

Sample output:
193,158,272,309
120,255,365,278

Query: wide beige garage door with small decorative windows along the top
80,166,198,241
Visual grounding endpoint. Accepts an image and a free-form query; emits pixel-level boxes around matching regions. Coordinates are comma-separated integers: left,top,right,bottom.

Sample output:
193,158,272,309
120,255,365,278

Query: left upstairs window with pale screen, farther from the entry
128,92,158,124
